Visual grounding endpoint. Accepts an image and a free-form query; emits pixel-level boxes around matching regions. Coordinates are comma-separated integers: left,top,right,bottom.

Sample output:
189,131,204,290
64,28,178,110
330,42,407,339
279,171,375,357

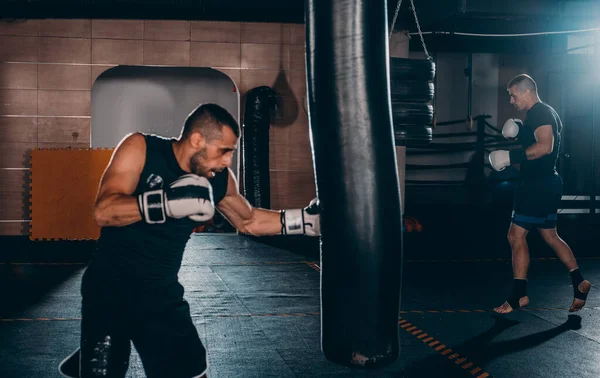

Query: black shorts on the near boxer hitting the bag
80,274,208,378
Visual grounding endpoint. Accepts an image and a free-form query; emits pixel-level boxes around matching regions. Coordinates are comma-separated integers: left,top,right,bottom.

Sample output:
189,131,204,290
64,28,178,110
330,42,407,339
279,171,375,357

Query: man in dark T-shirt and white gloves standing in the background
489,75,591,314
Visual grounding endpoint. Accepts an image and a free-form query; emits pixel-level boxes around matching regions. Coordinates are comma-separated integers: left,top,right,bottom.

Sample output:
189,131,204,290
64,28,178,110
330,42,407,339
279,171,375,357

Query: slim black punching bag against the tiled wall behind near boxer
242,86,278,209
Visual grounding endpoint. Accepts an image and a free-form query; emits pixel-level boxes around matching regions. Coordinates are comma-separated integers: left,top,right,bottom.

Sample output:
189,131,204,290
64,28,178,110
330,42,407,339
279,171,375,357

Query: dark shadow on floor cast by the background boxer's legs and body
398,315,581,378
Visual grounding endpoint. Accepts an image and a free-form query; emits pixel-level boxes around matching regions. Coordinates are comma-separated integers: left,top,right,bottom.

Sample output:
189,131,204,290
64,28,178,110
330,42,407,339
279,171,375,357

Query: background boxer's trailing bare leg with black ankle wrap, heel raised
538,228,592,312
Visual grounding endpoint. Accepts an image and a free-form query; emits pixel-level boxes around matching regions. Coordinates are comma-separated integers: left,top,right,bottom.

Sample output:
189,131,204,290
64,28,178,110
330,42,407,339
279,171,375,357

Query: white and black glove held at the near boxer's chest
138,173,215,224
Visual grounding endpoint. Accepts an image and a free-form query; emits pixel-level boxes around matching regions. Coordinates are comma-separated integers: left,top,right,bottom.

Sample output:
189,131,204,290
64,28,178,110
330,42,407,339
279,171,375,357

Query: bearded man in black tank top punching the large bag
60,104,320,378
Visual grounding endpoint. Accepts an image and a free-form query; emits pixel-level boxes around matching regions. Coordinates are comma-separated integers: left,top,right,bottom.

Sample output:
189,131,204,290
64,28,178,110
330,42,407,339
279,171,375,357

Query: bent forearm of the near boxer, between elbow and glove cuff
94,194,142,227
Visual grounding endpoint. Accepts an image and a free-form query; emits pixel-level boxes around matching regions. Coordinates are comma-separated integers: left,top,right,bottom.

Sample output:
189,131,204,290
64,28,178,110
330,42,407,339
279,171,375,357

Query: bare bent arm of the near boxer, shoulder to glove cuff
93,133,146,227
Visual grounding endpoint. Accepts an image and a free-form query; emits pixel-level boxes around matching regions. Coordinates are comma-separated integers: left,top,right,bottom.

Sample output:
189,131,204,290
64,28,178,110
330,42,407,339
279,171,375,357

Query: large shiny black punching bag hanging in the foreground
305,0,402,368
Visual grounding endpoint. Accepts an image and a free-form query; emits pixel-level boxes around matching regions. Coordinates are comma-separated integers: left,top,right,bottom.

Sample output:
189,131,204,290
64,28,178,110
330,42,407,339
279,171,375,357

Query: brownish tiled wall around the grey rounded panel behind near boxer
0,20,315,235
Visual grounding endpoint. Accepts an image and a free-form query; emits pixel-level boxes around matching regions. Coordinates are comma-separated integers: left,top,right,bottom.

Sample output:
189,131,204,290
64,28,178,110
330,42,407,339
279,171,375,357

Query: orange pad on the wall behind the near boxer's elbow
29,149,113,240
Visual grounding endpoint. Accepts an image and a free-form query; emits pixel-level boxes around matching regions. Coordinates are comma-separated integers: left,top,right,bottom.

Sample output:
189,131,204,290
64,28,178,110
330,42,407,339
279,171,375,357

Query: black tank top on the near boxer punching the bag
84,135,229,291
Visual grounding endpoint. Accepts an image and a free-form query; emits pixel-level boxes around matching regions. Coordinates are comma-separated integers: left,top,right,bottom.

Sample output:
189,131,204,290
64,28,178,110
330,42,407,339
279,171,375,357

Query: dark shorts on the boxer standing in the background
512,174,563,230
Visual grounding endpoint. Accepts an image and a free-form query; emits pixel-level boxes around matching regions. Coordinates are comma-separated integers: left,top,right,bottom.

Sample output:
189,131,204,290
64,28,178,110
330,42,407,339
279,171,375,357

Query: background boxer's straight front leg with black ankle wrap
494,223,529,314
